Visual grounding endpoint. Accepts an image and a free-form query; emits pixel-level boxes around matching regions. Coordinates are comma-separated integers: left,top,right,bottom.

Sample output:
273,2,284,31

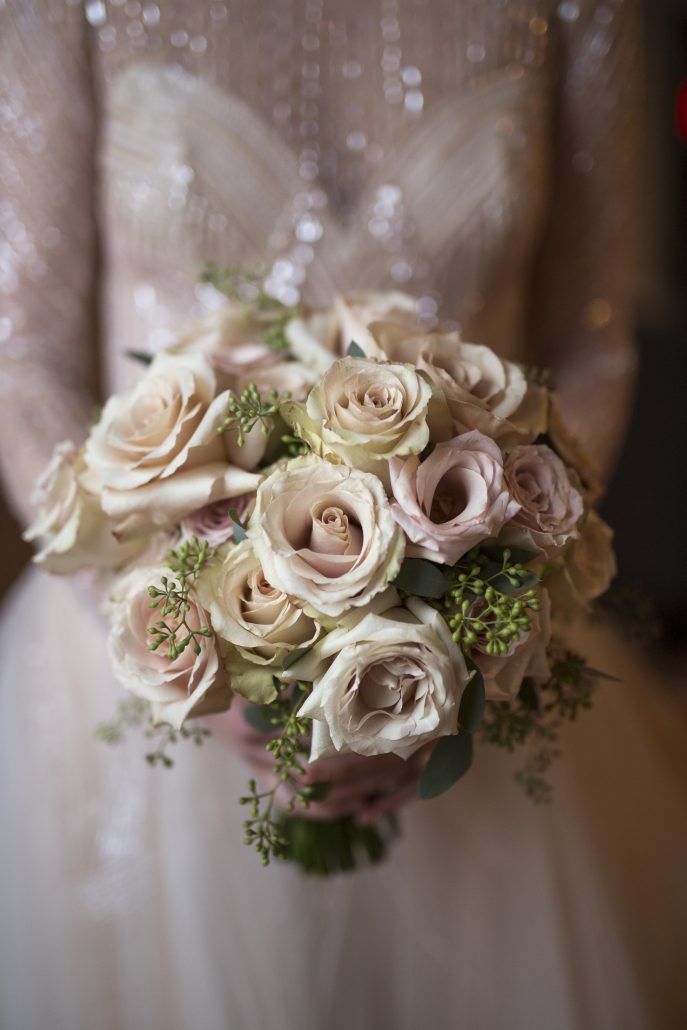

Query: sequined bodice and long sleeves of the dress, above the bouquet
0,0,637,523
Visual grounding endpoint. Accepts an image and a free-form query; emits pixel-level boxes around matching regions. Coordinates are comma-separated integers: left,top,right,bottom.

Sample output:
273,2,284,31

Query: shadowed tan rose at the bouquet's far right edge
547,511,617,618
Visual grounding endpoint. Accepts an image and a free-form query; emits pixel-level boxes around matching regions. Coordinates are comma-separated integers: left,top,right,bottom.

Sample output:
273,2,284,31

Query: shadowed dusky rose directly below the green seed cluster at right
470,590,551,701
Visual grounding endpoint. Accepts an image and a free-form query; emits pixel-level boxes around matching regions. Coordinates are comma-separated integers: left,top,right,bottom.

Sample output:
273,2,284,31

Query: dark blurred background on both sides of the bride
0,0,687,656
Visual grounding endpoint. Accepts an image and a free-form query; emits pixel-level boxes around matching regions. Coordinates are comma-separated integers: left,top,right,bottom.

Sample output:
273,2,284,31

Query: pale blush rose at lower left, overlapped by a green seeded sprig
108,565,231,729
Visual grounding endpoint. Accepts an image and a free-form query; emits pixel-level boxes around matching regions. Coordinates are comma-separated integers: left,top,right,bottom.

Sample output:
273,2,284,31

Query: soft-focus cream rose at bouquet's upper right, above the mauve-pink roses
372,323,547,442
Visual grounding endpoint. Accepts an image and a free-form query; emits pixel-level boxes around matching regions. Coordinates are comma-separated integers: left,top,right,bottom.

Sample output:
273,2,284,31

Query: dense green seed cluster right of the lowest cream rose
441,548,542,657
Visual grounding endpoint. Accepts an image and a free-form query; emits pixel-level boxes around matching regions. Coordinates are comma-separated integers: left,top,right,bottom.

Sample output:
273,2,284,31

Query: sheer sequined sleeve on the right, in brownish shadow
531,0,641,469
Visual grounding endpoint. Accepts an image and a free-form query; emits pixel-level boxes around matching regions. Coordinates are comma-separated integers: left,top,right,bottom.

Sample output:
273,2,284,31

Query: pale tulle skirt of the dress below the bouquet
0,572,687,1030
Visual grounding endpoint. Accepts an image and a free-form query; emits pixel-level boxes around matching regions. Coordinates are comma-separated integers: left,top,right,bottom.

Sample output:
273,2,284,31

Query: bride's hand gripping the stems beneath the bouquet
207,697,421,825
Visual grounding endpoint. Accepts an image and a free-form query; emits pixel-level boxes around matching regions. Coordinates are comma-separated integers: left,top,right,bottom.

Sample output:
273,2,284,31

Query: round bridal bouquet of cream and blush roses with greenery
28,269,614,872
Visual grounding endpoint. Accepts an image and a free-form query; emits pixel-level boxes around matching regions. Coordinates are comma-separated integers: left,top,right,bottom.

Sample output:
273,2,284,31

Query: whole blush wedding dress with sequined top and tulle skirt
0,0,687,1030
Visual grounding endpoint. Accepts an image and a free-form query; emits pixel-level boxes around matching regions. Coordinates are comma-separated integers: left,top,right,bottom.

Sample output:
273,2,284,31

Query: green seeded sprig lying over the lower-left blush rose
148,537,217,660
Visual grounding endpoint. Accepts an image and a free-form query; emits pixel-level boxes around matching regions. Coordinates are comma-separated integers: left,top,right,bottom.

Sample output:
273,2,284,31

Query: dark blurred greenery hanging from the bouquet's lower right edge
481,651,615,803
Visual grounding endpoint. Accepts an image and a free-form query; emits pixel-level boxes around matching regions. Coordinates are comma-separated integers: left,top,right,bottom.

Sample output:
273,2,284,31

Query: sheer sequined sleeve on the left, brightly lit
0,0,96,519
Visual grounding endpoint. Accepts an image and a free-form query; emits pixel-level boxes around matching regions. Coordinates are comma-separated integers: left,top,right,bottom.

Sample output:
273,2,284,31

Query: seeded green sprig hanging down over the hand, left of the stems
239,683,323,865
